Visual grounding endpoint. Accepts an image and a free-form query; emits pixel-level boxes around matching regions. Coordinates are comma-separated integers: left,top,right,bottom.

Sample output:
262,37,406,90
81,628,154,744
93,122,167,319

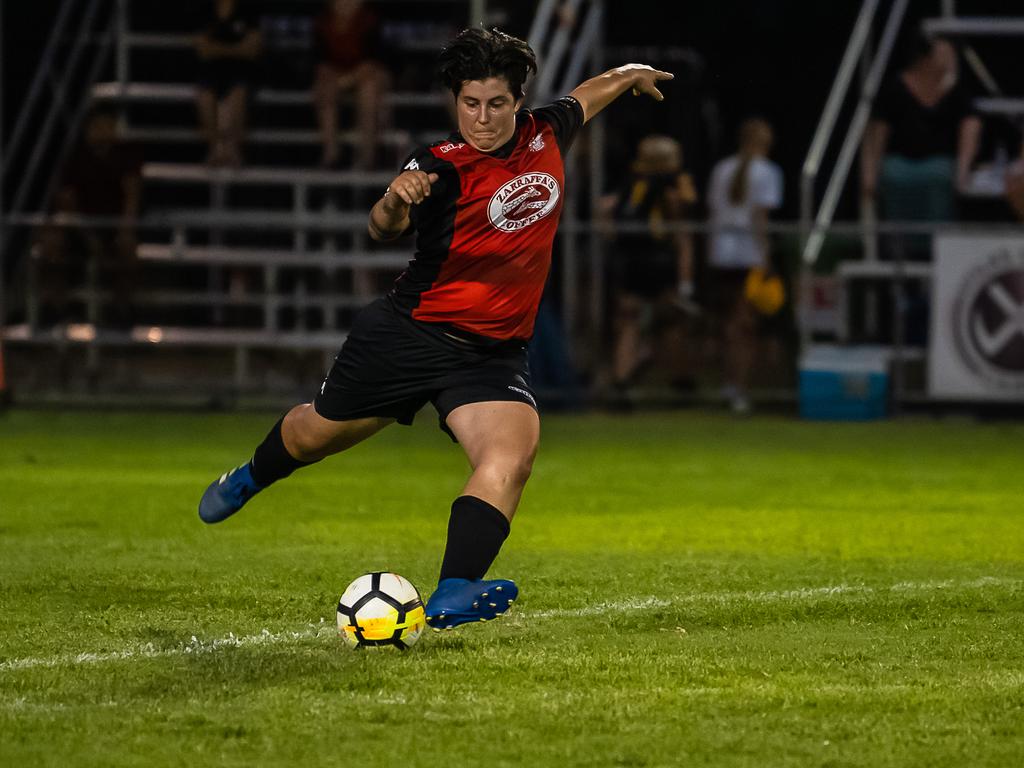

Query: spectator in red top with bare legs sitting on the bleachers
313,0,390,170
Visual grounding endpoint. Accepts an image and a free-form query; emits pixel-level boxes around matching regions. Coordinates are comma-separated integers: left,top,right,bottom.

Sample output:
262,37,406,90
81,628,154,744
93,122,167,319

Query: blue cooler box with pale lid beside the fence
800,345,889,421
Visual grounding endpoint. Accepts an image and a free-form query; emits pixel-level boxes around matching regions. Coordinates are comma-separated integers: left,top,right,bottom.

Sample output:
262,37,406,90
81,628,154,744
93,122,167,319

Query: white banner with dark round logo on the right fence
928,234,1024,402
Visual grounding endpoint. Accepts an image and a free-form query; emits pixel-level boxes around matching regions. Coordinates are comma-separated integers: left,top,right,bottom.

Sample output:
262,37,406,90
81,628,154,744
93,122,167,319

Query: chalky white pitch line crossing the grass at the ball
0,577,1024,672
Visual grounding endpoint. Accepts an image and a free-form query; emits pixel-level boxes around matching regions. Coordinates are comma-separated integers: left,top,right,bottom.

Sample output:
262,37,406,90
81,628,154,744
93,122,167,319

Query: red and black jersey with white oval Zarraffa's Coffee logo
391,96,584,340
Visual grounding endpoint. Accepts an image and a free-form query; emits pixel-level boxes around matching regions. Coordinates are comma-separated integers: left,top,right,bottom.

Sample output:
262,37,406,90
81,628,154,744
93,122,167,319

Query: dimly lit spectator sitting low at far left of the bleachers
37,112,142,326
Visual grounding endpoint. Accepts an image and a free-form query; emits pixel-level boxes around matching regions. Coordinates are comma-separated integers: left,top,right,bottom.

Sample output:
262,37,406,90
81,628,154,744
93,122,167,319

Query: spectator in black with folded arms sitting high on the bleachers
196,0,263,167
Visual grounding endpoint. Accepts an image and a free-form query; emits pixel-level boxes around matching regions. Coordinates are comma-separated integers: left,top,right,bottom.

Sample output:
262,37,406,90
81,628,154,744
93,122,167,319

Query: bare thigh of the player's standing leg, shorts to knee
446,400,541,474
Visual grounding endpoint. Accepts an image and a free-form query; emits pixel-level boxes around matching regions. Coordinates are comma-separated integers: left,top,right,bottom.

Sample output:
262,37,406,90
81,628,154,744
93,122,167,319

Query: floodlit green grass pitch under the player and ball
0,412,1024,768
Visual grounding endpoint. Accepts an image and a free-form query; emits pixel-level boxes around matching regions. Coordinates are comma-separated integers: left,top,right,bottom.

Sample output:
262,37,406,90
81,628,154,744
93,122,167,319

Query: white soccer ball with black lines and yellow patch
338,571,426,650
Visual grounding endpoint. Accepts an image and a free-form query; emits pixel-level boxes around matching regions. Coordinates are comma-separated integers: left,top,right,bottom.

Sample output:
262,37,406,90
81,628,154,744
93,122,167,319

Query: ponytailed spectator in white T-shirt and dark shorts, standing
708,119,782,414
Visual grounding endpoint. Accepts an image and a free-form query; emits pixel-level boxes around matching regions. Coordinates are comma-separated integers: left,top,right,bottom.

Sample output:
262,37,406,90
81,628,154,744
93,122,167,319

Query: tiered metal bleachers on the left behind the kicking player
0,0,603,399
